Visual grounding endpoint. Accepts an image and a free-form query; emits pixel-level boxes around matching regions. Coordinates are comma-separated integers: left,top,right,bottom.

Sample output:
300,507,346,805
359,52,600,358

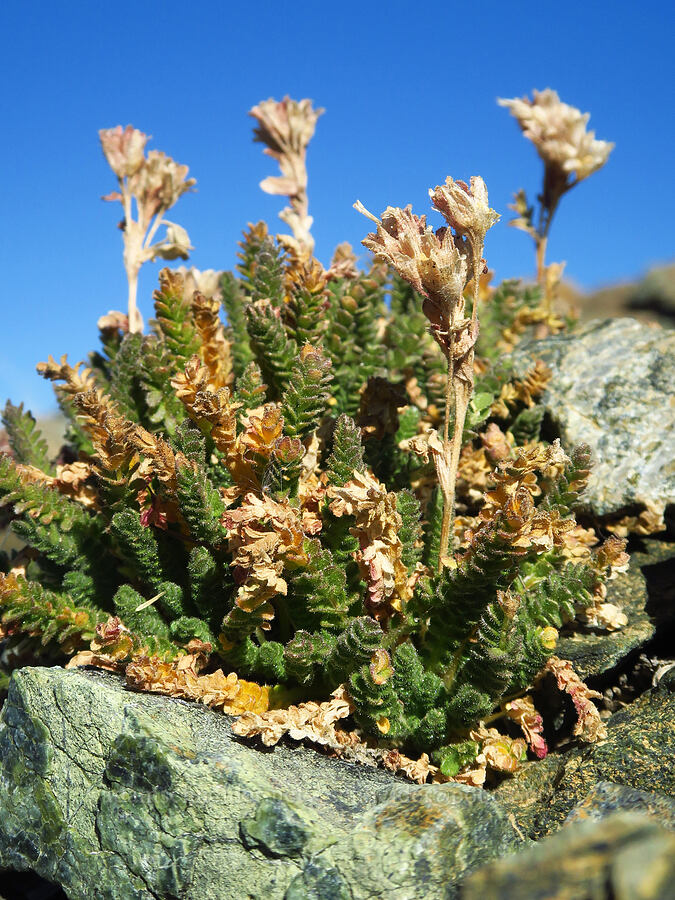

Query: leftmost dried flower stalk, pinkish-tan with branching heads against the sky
99,125,196,332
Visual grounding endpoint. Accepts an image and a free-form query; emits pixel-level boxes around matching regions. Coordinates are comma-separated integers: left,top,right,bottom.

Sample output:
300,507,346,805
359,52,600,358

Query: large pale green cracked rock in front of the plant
0,668,521,900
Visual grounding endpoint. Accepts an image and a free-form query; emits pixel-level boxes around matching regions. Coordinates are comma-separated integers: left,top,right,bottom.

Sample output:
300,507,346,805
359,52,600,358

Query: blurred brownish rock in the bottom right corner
462,813,675,900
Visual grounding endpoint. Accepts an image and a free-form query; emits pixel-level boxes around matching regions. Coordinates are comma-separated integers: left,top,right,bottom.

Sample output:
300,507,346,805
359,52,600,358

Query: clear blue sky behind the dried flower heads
0,0,675,412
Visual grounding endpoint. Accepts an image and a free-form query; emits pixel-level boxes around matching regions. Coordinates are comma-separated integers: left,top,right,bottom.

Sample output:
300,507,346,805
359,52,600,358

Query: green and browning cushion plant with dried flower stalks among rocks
0,88,627,783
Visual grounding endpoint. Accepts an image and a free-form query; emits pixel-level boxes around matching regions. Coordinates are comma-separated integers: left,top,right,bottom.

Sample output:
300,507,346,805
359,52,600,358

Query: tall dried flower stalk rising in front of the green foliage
354,176,499,570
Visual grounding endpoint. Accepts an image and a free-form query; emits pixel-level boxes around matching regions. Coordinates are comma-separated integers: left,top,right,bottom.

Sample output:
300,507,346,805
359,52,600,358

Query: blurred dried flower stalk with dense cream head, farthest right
497,88,614,312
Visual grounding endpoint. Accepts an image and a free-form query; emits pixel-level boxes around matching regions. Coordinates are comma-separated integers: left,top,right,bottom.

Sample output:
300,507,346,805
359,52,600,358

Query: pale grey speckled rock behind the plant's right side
515,319,675,516
